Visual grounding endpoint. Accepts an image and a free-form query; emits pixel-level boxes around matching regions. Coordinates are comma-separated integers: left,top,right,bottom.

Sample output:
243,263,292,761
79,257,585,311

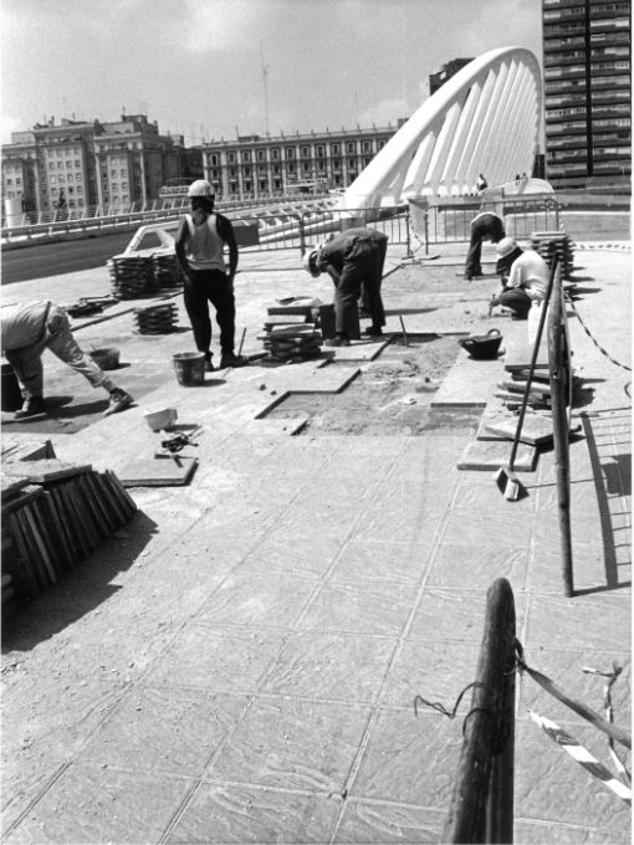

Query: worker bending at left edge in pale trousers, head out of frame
0,299,134,420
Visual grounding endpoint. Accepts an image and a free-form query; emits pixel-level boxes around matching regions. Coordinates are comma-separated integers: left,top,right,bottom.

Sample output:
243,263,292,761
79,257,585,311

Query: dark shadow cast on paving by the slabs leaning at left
2,504,158,654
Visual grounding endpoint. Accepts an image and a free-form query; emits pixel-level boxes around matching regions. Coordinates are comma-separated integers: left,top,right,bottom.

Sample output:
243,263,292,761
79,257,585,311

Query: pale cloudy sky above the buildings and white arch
0,0,542,145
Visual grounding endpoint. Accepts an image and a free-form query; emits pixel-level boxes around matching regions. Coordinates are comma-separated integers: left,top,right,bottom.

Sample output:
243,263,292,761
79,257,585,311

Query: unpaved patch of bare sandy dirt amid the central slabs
268,334,480,436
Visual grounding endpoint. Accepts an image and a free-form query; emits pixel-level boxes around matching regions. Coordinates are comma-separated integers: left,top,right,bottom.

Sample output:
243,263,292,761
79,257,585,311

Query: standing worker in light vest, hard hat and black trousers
176,179,246,372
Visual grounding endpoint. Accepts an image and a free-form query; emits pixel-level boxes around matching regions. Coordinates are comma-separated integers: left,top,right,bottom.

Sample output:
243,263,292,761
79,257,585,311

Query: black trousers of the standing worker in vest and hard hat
183,270,236,355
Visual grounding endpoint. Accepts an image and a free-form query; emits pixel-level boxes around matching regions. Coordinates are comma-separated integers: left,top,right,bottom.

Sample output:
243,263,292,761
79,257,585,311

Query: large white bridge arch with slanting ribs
340,47,542,210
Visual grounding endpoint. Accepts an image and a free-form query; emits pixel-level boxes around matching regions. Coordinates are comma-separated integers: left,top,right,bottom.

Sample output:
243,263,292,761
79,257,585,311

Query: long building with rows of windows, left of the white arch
202,121,403,201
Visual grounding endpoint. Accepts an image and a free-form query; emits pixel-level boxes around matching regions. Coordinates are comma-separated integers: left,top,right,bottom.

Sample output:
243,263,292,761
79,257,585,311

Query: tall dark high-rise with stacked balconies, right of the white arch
542,0,632,188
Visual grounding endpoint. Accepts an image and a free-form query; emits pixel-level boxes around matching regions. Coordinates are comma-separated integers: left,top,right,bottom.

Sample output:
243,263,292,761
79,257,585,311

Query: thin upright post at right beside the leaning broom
548,263,573,598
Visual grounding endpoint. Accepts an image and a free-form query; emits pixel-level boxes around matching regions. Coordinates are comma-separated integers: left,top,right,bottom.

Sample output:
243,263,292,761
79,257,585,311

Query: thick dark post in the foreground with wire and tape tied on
440,578,515,843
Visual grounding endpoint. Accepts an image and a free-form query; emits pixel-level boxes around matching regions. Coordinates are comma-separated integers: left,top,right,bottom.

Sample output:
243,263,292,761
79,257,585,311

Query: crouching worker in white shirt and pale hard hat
489,238,550,320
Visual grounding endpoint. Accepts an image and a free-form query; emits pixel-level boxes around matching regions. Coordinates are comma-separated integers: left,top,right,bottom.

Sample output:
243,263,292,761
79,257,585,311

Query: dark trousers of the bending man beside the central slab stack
335,242,387,335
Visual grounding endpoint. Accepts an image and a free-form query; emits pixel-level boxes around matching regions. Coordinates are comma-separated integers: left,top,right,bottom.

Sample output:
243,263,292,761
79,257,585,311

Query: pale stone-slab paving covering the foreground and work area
2,237,631,843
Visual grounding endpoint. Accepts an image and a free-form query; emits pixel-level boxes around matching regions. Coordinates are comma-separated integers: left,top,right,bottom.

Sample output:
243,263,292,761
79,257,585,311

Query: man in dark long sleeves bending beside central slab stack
303,227,388,346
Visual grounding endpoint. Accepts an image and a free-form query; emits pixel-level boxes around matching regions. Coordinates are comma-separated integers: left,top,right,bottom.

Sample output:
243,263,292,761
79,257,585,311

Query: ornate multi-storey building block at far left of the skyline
2,114,202,213
